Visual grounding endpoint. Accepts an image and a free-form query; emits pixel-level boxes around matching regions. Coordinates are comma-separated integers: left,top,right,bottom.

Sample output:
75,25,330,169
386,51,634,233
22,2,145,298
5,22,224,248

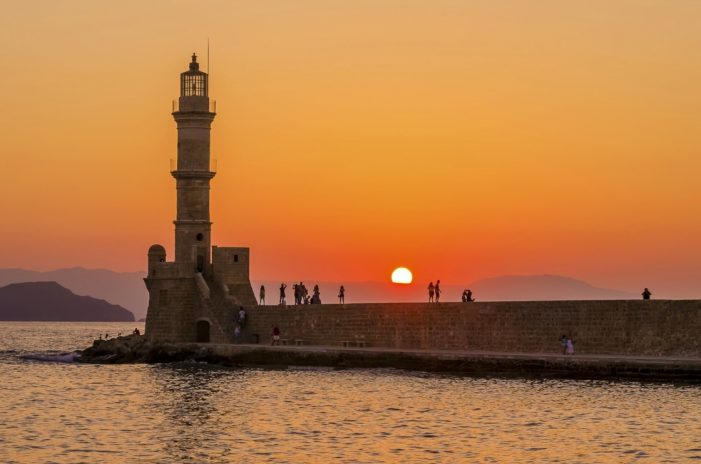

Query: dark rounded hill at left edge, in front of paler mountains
0,282,134,322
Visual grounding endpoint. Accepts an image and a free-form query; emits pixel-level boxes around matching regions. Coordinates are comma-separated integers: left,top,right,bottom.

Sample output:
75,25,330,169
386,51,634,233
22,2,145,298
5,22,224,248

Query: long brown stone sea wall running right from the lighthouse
244,300,701,357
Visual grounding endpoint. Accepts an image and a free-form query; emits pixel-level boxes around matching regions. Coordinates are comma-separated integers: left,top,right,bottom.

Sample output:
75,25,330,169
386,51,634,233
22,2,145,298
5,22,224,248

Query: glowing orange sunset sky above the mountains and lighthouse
0,0,701,296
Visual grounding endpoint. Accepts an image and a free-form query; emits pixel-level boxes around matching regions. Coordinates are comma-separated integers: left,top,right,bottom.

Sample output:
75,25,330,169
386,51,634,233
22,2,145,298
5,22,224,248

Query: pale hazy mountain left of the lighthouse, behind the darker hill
0,267,148,319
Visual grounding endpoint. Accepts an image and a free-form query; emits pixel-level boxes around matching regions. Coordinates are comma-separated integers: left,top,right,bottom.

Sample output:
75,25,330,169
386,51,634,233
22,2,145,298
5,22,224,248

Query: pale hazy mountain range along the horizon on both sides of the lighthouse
0,268,640,319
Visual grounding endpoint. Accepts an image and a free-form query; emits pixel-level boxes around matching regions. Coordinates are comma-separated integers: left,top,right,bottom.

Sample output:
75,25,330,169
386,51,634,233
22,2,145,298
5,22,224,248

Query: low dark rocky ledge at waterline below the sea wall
76,335,701,384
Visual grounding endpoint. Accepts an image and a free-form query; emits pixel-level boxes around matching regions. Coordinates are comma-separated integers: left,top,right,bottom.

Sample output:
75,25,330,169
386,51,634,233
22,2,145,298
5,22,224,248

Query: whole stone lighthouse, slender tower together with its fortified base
144,54,256,343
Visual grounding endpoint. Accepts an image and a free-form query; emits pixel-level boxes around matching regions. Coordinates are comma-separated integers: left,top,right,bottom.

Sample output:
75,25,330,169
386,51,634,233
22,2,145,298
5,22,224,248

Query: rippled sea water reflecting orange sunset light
0,322,701,463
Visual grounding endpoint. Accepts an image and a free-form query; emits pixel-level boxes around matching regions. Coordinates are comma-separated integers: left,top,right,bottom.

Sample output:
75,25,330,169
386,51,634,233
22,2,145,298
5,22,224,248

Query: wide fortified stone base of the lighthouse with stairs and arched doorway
144,245,256,343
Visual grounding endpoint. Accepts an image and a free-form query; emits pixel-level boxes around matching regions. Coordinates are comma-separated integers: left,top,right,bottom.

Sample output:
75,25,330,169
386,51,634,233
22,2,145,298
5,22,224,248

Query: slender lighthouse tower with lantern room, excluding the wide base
171,53,215,275
